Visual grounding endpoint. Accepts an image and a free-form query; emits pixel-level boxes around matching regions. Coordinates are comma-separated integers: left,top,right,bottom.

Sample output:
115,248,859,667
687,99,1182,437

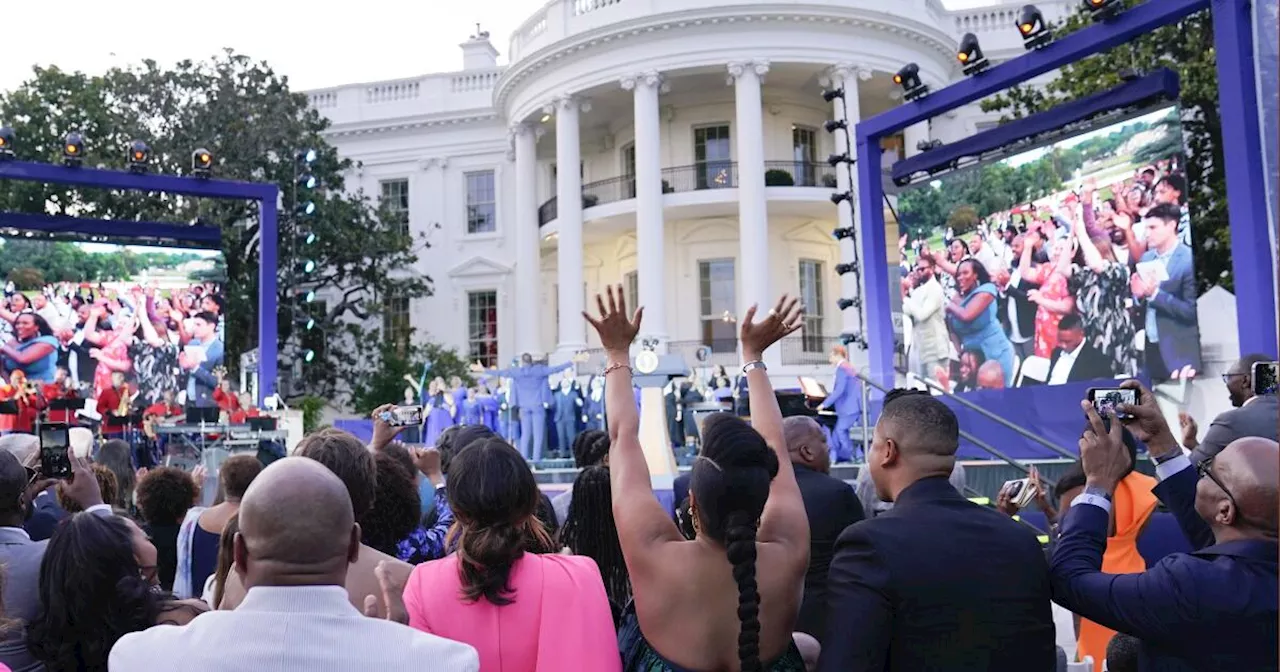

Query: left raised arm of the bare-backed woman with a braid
582,285,684,563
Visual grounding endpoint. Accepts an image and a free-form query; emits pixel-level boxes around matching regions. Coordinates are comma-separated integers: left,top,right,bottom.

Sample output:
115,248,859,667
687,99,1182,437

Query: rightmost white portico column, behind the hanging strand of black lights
827,63,872,334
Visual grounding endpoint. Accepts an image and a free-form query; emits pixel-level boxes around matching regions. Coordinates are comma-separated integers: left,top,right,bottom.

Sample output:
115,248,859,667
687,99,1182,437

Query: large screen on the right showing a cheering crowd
890,106,1201,392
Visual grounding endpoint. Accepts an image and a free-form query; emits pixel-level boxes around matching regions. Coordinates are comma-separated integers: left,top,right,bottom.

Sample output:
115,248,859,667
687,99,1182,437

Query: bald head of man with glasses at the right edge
1206,436,1280,539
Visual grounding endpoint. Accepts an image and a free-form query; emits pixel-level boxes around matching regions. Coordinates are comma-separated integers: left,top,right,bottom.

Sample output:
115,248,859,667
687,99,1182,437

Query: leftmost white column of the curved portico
511,123,543,355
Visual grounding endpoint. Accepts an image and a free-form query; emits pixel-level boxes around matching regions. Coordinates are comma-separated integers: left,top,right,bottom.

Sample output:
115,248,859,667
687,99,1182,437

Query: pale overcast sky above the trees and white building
0,0,992,91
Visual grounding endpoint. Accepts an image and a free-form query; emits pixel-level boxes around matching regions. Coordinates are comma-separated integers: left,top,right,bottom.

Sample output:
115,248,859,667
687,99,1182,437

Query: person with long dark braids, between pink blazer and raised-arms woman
553,466,631,625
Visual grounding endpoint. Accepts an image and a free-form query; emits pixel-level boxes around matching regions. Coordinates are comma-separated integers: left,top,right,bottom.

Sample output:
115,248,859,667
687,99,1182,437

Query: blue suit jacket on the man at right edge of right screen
1142,243,1201,371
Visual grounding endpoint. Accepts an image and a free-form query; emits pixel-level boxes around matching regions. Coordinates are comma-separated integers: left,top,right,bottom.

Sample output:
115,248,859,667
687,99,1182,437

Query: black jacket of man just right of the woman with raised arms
795,465,867,641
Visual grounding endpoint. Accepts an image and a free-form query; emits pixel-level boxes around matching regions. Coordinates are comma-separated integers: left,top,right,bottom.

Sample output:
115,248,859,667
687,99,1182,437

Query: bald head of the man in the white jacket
236,457,360,588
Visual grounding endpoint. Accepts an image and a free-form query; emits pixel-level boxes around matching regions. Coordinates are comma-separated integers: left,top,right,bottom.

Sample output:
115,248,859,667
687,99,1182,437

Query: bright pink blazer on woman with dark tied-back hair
404,553,622,672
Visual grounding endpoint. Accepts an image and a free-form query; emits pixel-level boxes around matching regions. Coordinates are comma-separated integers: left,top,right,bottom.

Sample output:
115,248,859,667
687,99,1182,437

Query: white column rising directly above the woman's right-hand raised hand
728,60,780,360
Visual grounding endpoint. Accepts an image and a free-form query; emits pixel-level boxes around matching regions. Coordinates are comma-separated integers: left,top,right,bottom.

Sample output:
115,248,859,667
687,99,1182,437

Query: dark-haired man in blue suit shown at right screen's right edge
1129,204,1201,380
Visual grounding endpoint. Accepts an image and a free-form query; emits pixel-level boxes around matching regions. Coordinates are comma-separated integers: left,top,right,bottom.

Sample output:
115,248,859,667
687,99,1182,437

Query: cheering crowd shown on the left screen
0,283,227,435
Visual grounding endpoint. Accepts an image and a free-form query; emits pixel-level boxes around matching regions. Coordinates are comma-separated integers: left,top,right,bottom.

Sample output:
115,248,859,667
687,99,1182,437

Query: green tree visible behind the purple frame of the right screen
982,0,1233,292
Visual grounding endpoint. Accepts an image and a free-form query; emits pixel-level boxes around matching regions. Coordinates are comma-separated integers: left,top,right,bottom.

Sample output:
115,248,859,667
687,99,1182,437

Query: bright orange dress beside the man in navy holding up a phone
1076,471,1157,672
